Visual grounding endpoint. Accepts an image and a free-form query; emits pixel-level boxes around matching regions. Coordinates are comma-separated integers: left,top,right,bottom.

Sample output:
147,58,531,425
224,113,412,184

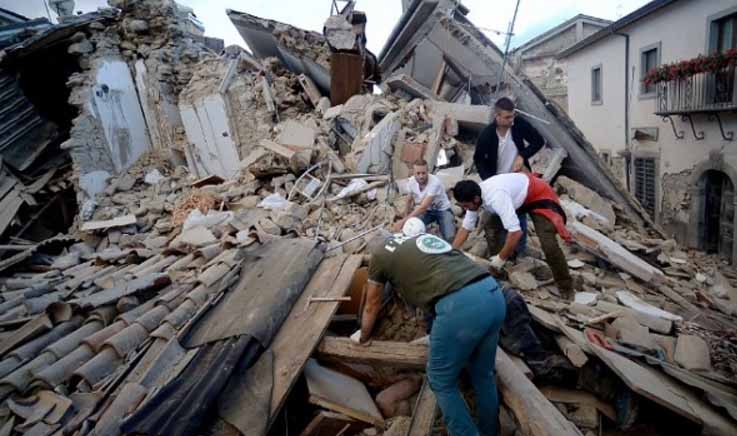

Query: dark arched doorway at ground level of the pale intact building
698,170,735,259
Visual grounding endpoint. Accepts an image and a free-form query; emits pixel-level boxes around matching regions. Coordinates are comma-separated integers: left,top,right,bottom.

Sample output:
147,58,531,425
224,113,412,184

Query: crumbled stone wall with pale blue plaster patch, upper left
63,0,212,217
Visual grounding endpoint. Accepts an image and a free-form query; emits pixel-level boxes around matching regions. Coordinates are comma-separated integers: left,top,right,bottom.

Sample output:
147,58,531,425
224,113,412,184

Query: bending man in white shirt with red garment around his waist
453,173,573,298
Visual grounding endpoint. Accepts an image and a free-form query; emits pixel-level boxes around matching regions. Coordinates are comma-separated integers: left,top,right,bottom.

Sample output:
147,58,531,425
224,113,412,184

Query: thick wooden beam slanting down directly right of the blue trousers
496,348,582,436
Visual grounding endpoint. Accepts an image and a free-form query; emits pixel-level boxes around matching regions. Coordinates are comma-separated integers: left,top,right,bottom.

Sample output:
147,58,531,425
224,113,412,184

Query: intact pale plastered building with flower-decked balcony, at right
560,0,737,260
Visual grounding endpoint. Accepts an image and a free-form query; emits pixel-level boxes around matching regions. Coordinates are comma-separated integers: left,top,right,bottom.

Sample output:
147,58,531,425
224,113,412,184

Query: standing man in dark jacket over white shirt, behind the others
473,97,545,254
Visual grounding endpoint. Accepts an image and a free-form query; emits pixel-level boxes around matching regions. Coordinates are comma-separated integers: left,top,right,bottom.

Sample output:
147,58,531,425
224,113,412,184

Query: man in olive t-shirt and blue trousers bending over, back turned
359,234,505,436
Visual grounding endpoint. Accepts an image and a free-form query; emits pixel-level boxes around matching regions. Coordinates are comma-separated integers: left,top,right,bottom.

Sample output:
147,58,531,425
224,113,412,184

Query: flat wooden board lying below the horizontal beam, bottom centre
305,359,384,428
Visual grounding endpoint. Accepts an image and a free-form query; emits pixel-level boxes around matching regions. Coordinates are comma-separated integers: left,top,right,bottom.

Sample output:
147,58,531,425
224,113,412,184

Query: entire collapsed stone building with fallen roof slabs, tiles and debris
0,0,737,436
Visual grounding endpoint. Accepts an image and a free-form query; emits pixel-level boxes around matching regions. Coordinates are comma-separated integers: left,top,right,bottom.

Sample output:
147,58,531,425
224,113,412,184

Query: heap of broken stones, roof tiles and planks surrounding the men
0,2,737,436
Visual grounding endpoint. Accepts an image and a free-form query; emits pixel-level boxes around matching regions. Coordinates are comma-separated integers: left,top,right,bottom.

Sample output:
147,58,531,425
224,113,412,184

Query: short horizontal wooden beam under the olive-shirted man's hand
317,337,427,369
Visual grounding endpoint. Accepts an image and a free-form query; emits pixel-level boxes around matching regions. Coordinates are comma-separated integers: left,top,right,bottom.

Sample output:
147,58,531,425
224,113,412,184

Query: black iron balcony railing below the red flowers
655,65,737,115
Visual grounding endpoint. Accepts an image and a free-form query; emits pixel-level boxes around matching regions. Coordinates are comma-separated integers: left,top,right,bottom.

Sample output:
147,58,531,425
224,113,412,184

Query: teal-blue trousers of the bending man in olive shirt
427,277,506,436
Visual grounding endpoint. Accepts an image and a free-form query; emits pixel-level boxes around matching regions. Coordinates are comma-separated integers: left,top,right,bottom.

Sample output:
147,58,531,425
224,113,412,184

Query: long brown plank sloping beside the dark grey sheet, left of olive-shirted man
269,256,362,425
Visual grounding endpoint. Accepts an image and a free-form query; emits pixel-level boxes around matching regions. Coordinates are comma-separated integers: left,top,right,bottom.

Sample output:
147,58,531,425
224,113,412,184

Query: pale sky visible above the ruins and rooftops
0,0,648,54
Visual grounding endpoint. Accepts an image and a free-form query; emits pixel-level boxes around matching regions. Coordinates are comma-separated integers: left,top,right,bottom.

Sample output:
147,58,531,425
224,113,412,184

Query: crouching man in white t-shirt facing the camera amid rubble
394,160,456,242
